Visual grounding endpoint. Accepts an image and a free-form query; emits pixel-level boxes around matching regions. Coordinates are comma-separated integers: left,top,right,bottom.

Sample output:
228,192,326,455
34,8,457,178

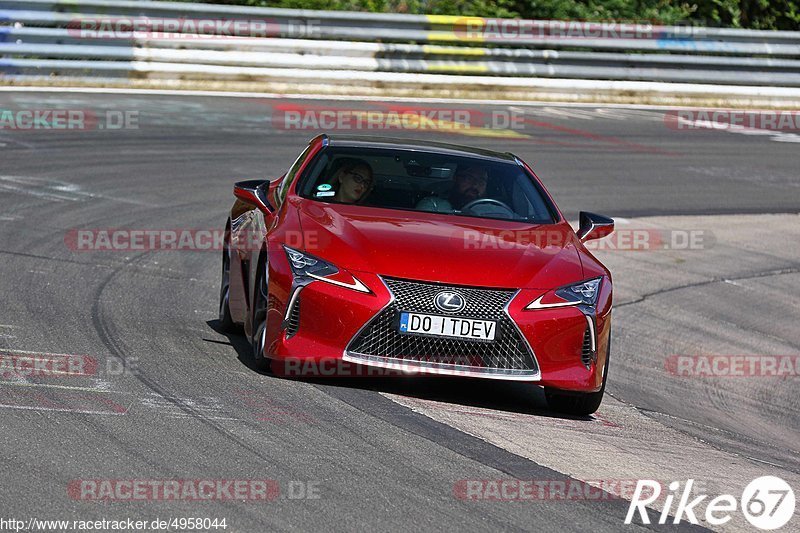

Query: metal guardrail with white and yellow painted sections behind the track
0,0,800,88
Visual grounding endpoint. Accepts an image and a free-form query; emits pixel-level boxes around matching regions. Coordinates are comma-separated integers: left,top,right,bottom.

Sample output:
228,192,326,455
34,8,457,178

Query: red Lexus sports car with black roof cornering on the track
219,135,614,414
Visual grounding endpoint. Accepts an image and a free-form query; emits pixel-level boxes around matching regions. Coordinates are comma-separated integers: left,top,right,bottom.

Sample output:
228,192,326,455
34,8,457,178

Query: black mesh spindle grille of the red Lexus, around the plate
347,278,539,379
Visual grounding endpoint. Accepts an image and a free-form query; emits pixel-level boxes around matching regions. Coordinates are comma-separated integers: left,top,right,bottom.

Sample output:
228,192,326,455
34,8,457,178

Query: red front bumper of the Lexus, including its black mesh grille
265,262,611,392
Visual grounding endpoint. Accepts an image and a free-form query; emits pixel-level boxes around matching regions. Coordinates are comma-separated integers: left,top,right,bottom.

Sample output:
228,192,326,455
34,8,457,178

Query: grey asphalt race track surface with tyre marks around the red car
0,91,800,531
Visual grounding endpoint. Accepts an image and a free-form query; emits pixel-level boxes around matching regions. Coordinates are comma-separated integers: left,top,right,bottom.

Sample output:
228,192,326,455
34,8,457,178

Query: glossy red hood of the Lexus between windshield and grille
297,201,583,289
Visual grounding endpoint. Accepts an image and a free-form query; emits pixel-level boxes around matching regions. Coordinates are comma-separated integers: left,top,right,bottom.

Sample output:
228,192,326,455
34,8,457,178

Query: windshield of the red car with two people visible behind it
298,147,554,224
